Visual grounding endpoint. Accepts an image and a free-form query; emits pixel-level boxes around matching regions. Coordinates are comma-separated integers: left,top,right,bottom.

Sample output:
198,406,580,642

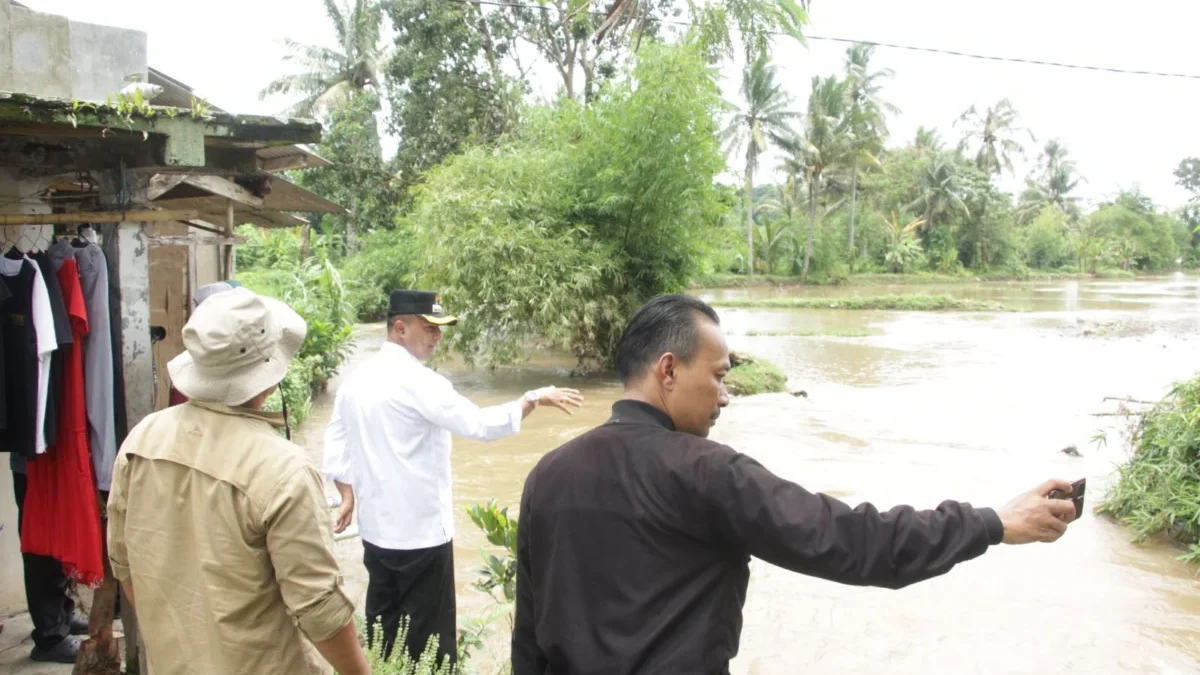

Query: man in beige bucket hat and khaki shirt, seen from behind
108,288,370,675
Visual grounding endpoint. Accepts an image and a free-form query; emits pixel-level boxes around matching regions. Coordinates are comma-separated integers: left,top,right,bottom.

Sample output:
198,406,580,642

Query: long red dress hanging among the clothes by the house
20,258,104,589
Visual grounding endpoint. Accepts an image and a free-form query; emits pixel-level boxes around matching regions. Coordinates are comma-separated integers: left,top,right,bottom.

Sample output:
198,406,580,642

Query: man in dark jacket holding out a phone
512,295,1075,675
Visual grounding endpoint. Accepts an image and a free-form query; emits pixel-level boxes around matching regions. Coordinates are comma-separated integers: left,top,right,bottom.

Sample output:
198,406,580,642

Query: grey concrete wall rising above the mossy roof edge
0,0,148,102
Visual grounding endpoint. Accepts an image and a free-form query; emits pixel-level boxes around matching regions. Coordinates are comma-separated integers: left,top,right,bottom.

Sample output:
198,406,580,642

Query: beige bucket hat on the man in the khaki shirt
167,288,308,406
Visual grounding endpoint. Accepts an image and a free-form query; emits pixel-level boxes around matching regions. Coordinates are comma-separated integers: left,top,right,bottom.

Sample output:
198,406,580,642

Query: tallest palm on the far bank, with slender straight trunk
846,43,900,256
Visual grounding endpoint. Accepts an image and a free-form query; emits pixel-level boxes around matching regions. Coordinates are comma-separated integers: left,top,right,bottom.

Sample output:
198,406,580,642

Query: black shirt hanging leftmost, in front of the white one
0,261,38,458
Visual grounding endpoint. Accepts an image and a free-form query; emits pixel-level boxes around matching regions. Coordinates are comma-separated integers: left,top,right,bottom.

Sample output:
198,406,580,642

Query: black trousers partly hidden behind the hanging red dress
12,473,74,650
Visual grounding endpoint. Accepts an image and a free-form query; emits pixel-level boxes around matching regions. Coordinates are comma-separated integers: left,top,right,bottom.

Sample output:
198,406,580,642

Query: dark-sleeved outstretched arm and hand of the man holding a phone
706,452,1074,589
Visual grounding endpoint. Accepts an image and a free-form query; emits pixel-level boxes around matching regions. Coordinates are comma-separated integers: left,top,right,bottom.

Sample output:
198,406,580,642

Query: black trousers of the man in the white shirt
362,540,458,663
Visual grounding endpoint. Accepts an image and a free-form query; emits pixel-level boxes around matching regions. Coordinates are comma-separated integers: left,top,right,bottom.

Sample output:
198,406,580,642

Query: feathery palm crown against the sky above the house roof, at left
258,0,384,118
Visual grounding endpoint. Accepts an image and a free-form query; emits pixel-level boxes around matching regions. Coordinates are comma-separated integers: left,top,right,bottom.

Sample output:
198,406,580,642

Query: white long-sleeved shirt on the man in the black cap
322,342,522,550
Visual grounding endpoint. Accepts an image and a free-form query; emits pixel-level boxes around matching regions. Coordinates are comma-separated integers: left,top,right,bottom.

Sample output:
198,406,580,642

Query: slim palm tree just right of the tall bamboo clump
721,58,799,276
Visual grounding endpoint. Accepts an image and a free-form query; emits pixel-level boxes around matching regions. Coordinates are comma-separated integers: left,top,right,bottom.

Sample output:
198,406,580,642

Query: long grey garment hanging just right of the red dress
49,239,116,492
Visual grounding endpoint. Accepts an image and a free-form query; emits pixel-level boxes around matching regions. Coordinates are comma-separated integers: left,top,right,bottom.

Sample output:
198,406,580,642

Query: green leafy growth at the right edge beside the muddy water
1097,377,1200,562
